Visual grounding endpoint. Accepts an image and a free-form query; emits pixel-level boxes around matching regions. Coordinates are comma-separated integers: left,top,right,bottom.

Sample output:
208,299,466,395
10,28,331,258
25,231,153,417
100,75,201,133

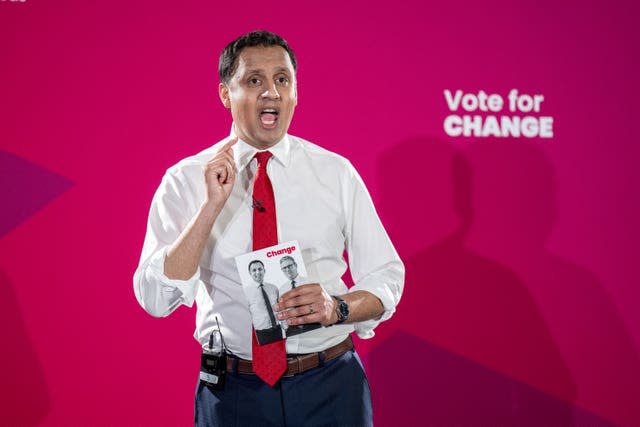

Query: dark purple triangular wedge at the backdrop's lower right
367,332,615,427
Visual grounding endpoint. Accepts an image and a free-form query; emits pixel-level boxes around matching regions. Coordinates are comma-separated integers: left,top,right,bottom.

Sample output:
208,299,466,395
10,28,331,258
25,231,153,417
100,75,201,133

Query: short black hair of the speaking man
218,31,296,83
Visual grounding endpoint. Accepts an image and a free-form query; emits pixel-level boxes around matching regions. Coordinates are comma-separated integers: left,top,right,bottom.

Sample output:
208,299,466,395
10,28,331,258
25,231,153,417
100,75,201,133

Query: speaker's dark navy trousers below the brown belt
195,350,373,427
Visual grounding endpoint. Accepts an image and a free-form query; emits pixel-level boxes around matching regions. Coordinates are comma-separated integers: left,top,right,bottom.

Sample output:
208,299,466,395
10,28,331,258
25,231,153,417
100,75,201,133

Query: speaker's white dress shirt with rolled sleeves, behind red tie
133,135,404,359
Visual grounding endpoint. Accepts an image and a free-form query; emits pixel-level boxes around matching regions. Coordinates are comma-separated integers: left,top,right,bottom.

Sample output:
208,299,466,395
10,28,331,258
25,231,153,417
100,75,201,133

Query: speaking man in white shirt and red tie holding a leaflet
134,31,404,426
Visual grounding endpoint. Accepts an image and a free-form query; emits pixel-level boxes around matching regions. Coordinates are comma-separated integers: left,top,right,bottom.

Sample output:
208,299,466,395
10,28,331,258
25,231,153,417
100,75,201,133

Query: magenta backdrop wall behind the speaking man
0,0,640,426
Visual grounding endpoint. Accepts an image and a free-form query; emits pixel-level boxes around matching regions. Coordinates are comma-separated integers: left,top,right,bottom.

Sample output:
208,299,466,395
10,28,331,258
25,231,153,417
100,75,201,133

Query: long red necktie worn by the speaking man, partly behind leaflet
251,151,287,387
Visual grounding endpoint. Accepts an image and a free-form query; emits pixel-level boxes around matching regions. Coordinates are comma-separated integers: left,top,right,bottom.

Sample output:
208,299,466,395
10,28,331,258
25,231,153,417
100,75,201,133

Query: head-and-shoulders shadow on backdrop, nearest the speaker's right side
367,138,584,426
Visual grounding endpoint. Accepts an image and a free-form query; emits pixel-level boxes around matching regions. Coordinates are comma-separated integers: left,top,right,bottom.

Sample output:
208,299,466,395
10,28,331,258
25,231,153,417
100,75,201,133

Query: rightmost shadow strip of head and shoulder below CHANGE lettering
466,142,640,426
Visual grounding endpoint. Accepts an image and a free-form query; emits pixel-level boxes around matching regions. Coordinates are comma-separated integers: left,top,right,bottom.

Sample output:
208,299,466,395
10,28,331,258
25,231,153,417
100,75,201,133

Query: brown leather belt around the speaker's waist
227,336,353,377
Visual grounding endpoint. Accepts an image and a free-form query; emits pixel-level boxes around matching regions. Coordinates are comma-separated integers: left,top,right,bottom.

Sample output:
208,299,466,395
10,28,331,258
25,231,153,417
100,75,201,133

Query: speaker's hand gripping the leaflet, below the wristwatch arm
274,283,338,326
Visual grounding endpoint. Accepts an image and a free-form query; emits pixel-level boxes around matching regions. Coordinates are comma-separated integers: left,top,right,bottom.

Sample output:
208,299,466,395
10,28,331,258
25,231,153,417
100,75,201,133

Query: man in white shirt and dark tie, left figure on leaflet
246,260,282,344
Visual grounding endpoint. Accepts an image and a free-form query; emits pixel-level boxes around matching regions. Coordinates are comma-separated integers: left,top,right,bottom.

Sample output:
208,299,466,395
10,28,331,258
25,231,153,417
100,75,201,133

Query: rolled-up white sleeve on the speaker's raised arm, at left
133,169,200,317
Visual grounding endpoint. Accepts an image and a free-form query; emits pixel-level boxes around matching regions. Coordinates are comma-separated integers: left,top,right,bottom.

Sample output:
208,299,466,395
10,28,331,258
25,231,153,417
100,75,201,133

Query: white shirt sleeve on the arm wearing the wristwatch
342,160,404,338
